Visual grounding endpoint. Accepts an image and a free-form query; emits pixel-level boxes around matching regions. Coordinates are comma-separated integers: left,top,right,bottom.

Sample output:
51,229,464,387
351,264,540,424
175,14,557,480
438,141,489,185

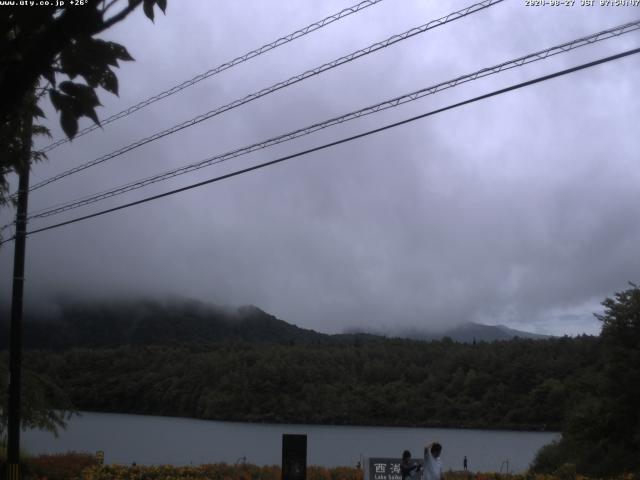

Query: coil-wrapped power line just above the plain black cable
29,20,640,219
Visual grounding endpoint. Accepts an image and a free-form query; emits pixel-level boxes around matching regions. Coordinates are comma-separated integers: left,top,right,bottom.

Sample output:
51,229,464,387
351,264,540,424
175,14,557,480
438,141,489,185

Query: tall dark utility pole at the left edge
6,109,33,480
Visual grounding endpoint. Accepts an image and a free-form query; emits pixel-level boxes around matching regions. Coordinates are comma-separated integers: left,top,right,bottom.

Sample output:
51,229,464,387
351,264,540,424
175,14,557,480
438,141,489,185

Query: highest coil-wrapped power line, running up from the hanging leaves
40,0,382,153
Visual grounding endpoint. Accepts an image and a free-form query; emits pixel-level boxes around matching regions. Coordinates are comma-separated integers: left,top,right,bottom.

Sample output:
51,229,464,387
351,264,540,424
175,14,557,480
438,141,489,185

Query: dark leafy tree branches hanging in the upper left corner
0,0,167,203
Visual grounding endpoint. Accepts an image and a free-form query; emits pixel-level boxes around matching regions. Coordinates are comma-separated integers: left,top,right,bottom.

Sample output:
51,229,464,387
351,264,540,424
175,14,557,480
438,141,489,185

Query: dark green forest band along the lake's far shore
25,337,597,430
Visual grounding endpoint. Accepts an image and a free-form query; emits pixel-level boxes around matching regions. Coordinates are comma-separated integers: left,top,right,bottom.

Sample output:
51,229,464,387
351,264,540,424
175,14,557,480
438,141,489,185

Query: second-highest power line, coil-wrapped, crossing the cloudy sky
23,0,504,195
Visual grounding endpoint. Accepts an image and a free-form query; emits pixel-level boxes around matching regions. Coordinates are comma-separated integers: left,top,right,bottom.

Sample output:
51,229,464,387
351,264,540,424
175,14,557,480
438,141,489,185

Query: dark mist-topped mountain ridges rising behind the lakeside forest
0,300,545,350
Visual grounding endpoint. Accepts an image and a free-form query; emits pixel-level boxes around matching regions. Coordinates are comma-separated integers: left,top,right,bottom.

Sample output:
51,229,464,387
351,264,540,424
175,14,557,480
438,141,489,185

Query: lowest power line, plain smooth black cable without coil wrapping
2,48,640,243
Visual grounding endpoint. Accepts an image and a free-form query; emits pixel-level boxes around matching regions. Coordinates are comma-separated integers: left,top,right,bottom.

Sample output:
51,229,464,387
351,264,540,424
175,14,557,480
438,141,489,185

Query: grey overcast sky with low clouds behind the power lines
0,0,640,335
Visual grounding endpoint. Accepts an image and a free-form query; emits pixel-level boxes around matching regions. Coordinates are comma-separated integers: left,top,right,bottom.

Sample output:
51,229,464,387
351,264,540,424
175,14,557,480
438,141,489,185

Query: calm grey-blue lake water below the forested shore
22,413,559,472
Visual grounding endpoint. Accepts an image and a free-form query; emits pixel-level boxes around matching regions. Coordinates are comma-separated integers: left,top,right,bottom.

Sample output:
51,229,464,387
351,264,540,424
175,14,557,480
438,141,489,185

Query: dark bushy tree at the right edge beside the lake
534,284,640,476
